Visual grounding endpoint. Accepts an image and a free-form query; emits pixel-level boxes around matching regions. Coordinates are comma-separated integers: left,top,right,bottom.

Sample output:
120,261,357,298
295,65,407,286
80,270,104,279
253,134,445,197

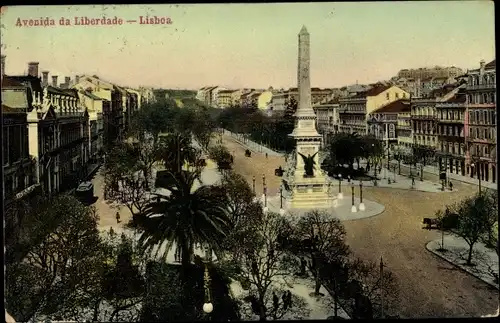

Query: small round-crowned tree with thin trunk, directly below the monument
294,210,349,295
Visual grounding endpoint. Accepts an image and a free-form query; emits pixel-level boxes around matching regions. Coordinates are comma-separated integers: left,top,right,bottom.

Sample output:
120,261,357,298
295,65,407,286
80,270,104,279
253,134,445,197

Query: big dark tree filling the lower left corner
6,195,100,321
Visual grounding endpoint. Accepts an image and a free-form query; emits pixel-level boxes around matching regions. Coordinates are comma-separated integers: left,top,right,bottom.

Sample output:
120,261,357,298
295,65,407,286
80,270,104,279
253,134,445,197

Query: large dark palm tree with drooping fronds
136,170,232,271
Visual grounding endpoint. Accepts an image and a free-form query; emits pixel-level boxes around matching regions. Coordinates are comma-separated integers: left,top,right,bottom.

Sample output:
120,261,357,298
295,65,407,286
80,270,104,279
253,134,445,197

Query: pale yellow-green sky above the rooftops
1,1,495,89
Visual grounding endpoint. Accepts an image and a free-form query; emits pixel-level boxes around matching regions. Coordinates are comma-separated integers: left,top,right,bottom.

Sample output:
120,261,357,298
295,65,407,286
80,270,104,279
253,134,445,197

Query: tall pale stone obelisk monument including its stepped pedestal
290,26,332,209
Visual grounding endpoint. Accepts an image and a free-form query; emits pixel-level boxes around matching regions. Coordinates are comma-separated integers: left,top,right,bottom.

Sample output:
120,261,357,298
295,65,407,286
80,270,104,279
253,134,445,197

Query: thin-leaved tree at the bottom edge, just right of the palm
224,213,304,320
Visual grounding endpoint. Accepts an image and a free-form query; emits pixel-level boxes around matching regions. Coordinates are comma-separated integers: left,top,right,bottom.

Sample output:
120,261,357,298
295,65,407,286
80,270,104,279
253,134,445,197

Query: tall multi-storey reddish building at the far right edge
465,60,497,183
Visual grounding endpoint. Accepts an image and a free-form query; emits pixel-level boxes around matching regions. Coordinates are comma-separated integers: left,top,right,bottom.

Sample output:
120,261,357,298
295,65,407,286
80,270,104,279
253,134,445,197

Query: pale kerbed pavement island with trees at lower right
425,234,499,289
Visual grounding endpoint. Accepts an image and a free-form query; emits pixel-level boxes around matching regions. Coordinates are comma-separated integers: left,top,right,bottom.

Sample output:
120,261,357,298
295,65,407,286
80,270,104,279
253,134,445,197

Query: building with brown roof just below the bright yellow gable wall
367,99,411,148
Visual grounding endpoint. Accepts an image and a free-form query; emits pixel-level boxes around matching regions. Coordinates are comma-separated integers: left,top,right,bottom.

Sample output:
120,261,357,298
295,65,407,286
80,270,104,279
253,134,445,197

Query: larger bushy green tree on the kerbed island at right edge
451,193,498,266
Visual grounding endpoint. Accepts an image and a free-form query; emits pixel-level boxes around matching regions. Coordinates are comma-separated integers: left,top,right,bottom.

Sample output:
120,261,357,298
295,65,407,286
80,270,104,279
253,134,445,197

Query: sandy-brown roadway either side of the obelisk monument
223,136,498,318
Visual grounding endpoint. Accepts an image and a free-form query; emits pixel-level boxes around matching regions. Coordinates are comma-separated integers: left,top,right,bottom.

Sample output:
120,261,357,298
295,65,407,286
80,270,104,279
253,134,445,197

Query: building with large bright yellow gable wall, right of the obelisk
339,85,410,134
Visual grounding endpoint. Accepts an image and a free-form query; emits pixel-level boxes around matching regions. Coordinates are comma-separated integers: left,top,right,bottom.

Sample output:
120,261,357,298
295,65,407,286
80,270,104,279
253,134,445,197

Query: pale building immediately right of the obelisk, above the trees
313,98,340,146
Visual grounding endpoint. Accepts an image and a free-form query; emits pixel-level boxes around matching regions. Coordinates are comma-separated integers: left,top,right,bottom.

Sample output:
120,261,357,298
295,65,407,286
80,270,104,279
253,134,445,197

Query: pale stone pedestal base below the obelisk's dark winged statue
290,175,335,209
